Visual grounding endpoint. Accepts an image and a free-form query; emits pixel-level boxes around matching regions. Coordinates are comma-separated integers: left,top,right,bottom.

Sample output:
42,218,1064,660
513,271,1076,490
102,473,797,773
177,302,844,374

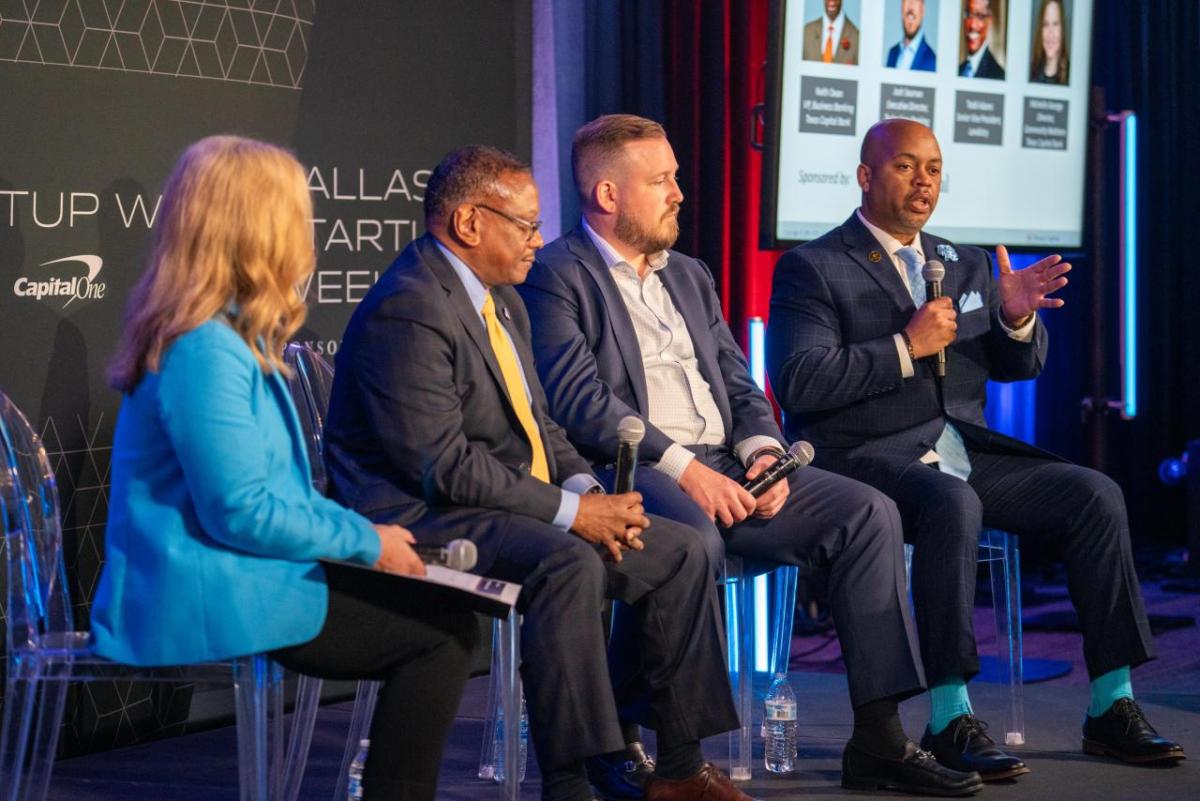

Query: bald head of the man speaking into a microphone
858,119,942,243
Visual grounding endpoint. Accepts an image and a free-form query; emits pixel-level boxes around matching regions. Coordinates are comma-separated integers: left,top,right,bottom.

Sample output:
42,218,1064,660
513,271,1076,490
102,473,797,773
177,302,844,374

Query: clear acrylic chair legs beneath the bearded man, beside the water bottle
722,555,799,782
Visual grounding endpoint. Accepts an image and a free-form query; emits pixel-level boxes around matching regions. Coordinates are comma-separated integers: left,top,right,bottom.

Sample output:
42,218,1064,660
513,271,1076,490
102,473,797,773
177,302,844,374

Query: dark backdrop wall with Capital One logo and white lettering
0,0,530,753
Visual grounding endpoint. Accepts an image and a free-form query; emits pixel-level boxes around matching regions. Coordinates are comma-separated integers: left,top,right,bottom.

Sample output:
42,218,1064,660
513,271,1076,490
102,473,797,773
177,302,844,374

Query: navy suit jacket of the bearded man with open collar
517,225,782,464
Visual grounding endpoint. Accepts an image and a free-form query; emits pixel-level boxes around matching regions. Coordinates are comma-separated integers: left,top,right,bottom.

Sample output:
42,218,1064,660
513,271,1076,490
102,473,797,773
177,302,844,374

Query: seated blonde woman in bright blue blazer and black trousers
91,137,478,801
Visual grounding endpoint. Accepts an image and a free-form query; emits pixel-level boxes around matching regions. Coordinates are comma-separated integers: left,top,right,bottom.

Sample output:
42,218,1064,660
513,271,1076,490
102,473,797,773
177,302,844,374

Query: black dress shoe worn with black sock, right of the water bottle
841,741,983,796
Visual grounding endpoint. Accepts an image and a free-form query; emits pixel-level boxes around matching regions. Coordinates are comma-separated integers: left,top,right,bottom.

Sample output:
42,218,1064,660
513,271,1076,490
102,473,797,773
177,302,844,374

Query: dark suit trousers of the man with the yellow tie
410,510,738,773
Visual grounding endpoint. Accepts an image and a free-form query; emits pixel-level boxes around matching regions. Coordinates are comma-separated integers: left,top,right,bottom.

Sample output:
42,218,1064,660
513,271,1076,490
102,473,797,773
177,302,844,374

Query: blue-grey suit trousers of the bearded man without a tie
600,445,924,706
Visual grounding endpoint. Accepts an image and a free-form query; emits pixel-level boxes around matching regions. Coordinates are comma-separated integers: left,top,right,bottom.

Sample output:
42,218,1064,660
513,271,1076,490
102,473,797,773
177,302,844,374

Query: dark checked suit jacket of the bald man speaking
767,215,1057,477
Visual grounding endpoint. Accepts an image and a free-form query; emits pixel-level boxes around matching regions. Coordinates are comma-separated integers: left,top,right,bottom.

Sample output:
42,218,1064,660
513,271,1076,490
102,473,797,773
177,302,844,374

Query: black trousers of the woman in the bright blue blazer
271,564,479,801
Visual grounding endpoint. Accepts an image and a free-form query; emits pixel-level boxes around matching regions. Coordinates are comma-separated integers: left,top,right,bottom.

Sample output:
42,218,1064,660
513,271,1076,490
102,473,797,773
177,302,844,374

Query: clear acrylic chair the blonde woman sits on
0,392,300,801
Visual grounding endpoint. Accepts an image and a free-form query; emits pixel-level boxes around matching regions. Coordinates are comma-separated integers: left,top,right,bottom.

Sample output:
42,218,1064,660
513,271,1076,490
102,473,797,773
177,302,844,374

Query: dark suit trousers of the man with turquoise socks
870,444,1154,683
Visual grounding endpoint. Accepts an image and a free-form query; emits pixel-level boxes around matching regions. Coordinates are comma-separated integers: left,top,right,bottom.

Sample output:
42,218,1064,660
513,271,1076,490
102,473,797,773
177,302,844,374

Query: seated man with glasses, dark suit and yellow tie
325,146,748,801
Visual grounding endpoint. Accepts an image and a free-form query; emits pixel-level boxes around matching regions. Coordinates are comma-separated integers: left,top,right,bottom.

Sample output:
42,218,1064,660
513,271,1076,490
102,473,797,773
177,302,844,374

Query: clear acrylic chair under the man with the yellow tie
281,342,521,801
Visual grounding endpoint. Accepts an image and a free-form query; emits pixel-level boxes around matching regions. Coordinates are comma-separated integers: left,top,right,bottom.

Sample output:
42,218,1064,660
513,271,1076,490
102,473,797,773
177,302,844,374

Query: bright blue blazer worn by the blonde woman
91,319,379,666
